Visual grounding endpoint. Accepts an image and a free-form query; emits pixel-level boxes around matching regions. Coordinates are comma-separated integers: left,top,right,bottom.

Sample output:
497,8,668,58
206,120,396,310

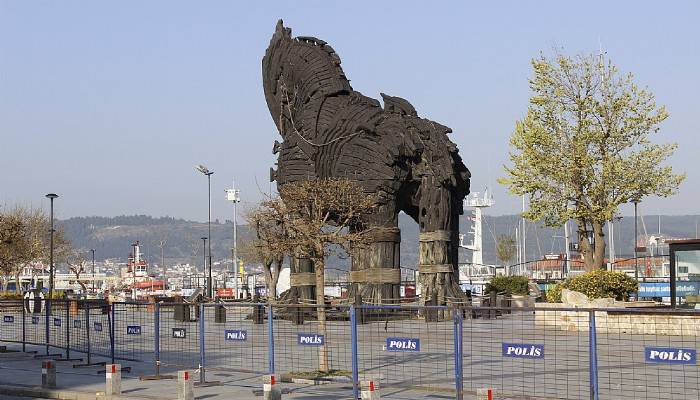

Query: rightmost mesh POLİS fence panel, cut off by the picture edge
596,310,700,399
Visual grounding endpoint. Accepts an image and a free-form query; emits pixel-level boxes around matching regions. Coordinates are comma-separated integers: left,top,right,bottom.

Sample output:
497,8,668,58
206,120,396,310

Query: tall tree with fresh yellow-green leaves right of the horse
499,54,685,270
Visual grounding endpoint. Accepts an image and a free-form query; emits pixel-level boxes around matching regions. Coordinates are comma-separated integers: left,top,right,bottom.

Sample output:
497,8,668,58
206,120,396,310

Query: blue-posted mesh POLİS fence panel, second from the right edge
463,307,590,399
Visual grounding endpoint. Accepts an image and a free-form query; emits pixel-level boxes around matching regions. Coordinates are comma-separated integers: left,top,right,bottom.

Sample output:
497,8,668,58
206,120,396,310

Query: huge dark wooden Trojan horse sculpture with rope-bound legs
262,20,470,304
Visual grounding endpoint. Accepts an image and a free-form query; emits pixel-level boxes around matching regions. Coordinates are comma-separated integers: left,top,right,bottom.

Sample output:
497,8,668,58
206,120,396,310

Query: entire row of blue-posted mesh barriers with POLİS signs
0,300,700,399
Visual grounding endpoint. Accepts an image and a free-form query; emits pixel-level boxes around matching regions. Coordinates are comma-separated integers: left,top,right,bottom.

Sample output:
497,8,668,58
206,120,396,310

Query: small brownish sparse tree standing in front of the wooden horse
251,179,376,372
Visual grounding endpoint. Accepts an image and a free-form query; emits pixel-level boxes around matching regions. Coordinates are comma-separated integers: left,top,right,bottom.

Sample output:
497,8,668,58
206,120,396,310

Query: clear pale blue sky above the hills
0,0,700,221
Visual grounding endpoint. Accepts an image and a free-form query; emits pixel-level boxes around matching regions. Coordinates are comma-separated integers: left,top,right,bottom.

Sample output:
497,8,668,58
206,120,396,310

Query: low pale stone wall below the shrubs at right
535,304,700,336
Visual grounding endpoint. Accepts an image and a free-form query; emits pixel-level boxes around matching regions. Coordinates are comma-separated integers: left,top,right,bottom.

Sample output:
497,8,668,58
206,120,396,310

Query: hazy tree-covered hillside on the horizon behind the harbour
58,215,700,268
